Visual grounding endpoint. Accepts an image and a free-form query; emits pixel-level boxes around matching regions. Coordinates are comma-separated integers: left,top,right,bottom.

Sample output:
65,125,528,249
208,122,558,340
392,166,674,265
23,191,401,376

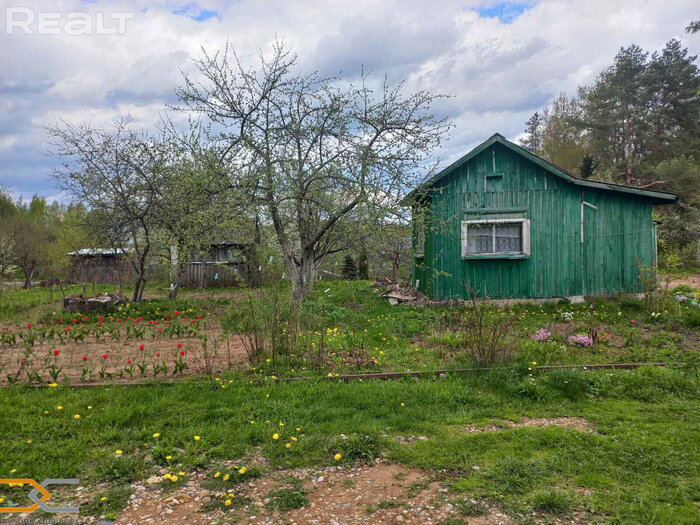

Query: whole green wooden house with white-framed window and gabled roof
406,134,677,299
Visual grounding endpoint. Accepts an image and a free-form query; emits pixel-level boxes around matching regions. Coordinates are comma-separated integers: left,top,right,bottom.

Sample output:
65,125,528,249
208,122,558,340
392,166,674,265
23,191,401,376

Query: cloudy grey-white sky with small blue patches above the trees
0,0,700,200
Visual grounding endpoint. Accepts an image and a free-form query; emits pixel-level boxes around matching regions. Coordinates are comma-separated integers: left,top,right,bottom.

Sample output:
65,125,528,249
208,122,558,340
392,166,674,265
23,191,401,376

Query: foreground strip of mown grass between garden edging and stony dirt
0,368,700,523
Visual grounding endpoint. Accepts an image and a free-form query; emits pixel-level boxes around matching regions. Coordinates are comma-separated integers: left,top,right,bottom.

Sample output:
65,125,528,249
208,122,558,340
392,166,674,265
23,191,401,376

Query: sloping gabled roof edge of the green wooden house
404,133,678,204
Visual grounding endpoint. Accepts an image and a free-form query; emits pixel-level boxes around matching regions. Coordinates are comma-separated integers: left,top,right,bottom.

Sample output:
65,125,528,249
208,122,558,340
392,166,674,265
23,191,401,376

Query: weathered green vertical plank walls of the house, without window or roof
413,144,656,299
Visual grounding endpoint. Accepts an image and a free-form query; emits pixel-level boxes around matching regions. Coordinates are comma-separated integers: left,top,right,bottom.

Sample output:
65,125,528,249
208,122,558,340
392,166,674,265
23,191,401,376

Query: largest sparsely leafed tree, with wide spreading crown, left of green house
176,43,449,302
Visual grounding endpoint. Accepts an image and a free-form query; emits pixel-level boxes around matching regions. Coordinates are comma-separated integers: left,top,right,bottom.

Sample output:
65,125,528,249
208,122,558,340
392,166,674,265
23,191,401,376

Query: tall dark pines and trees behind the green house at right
521,30,700,267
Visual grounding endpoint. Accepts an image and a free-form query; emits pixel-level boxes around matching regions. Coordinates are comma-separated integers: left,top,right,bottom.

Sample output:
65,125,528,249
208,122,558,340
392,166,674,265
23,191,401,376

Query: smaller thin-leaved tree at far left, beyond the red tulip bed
44,119,168,301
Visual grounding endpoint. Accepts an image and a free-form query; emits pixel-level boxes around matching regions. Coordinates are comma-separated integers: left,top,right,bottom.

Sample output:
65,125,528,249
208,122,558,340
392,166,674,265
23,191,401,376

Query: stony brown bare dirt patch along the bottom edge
115,462,512,525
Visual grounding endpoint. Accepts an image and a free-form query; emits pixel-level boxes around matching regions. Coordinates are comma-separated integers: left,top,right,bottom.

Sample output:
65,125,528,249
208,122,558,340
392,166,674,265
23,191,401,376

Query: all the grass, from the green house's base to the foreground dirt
0,282,700,523
